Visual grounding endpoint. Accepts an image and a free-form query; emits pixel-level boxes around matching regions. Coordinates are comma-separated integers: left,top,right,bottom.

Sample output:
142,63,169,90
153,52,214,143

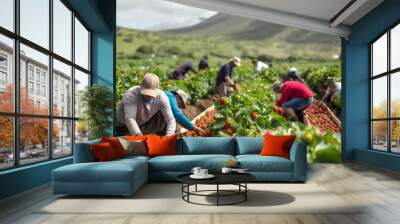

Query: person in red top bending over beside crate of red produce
274,81,314,121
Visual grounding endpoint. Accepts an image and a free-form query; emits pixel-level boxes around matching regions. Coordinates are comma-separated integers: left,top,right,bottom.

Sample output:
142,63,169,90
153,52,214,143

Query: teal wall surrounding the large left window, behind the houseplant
0,0,116,199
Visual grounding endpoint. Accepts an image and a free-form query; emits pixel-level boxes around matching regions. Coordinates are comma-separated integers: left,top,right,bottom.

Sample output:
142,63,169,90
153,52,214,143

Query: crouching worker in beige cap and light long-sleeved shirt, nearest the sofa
117,73,176,136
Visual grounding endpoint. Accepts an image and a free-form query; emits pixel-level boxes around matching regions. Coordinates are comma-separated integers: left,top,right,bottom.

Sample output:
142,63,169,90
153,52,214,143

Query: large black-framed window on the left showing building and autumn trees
0,0,91,170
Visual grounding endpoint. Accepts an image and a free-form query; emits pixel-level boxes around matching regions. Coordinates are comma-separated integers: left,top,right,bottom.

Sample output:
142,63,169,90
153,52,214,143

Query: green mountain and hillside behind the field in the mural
117,13,340,60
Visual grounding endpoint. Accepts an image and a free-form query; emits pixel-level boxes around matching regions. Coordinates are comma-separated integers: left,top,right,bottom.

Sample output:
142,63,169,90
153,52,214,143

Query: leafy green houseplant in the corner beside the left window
80,84,113,139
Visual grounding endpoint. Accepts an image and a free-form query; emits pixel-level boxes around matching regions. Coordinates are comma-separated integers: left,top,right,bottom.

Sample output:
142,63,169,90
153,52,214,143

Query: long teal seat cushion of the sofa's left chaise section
52,158,148,183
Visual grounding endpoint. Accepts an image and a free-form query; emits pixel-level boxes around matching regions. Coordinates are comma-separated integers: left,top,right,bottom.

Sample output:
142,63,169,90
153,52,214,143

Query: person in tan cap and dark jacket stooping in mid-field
215,57,241,97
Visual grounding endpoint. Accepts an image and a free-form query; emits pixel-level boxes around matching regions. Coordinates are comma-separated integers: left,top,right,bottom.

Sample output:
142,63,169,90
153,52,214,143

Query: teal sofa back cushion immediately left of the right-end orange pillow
236,137,264,155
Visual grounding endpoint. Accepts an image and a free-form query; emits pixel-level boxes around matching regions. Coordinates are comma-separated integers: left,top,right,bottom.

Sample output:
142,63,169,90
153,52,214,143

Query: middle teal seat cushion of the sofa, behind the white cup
149,154,235,172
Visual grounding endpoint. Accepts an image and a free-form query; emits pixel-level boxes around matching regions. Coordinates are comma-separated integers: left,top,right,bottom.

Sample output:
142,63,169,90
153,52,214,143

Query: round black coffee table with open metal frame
177,173,255,206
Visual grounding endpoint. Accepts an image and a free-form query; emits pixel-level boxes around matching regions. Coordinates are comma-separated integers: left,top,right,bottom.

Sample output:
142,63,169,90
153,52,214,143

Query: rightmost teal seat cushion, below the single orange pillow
236,155,293,172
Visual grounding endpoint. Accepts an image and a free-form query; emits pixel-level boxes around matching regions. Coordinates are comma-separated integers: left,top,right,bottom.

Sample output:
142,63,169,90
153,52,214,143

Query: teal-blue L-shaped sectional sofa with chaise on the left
52,137,307,195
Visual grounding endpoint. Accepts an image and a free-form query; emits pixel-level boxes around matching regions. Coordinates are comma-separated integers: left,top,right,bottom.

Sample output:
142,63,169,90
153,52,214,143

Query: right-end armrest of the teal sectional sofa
290,142,307,181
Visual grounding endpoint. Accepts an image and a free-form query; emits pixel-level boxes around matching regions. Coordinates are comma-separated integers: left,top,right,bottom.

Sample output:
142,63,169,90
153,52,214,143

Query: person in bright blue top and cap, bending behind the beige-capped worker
165,89,202,132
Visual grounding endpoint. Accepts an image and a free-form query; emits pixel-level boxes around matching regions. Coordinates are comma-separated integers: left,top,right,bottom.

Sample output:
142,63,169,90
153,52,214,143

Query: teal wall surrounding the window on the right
342,0,400,172
